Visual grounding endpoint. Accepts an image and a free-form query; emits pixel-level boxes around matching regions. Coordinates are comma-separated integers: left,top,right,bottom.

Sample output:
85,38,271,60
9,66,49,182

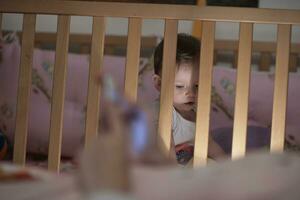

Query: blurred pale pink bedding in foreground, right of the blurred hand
133,152,300,200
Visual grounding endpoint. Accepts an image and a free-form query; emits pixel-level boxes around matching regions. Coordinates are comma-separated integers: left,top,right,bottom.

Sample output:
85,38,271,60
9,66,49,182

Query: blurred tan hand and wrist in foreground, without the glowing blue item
79,102,130,199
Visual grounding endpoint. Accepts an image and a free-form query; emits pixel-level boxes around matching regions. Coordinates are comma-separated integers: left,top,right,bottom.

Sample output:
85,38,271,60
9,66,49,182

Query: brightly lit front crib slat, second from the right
231,23,253,159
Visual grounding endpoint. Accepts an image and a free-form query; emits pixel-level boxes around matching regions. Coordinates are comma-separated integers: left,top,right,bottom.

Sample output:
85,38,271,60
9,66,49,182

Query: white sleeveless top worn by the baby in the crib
151,100,196,145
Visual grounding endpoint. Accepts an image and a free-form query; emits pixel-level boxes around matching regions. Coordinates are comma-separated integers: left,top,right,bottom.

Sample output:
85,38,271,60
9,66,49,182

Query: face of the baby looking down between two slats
173,63,199,114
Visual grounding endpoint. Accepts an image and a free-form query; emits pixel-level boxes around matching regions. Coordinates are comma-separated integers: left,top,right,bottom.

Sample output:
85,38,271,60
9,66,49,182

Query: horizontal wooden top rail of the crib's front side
0,0,300,24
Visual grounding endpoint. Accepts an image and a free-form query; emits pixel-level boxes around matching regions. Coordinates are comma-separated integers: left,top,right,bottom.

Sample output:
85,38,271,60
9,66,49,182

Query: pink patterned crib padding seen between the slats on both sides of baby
0,36,300,156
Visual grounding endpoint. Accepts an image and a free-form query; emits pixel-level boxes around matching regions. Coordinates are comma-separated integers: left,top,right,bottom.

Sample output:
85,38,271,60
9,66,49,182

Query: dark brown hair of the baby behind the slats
154,33,200,75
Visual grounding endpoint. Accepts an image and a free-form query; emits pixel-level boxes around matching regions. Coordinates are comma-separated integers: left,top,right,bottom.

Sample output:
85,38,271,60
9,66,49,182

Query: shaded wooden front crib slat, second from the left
48,15,71,171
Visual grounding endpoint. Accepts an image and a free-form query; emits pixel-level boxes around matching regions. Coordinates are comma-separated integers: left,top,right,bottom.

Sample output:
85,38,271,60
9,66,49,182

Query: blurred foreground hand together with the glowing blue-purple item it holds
78,76,171,199
